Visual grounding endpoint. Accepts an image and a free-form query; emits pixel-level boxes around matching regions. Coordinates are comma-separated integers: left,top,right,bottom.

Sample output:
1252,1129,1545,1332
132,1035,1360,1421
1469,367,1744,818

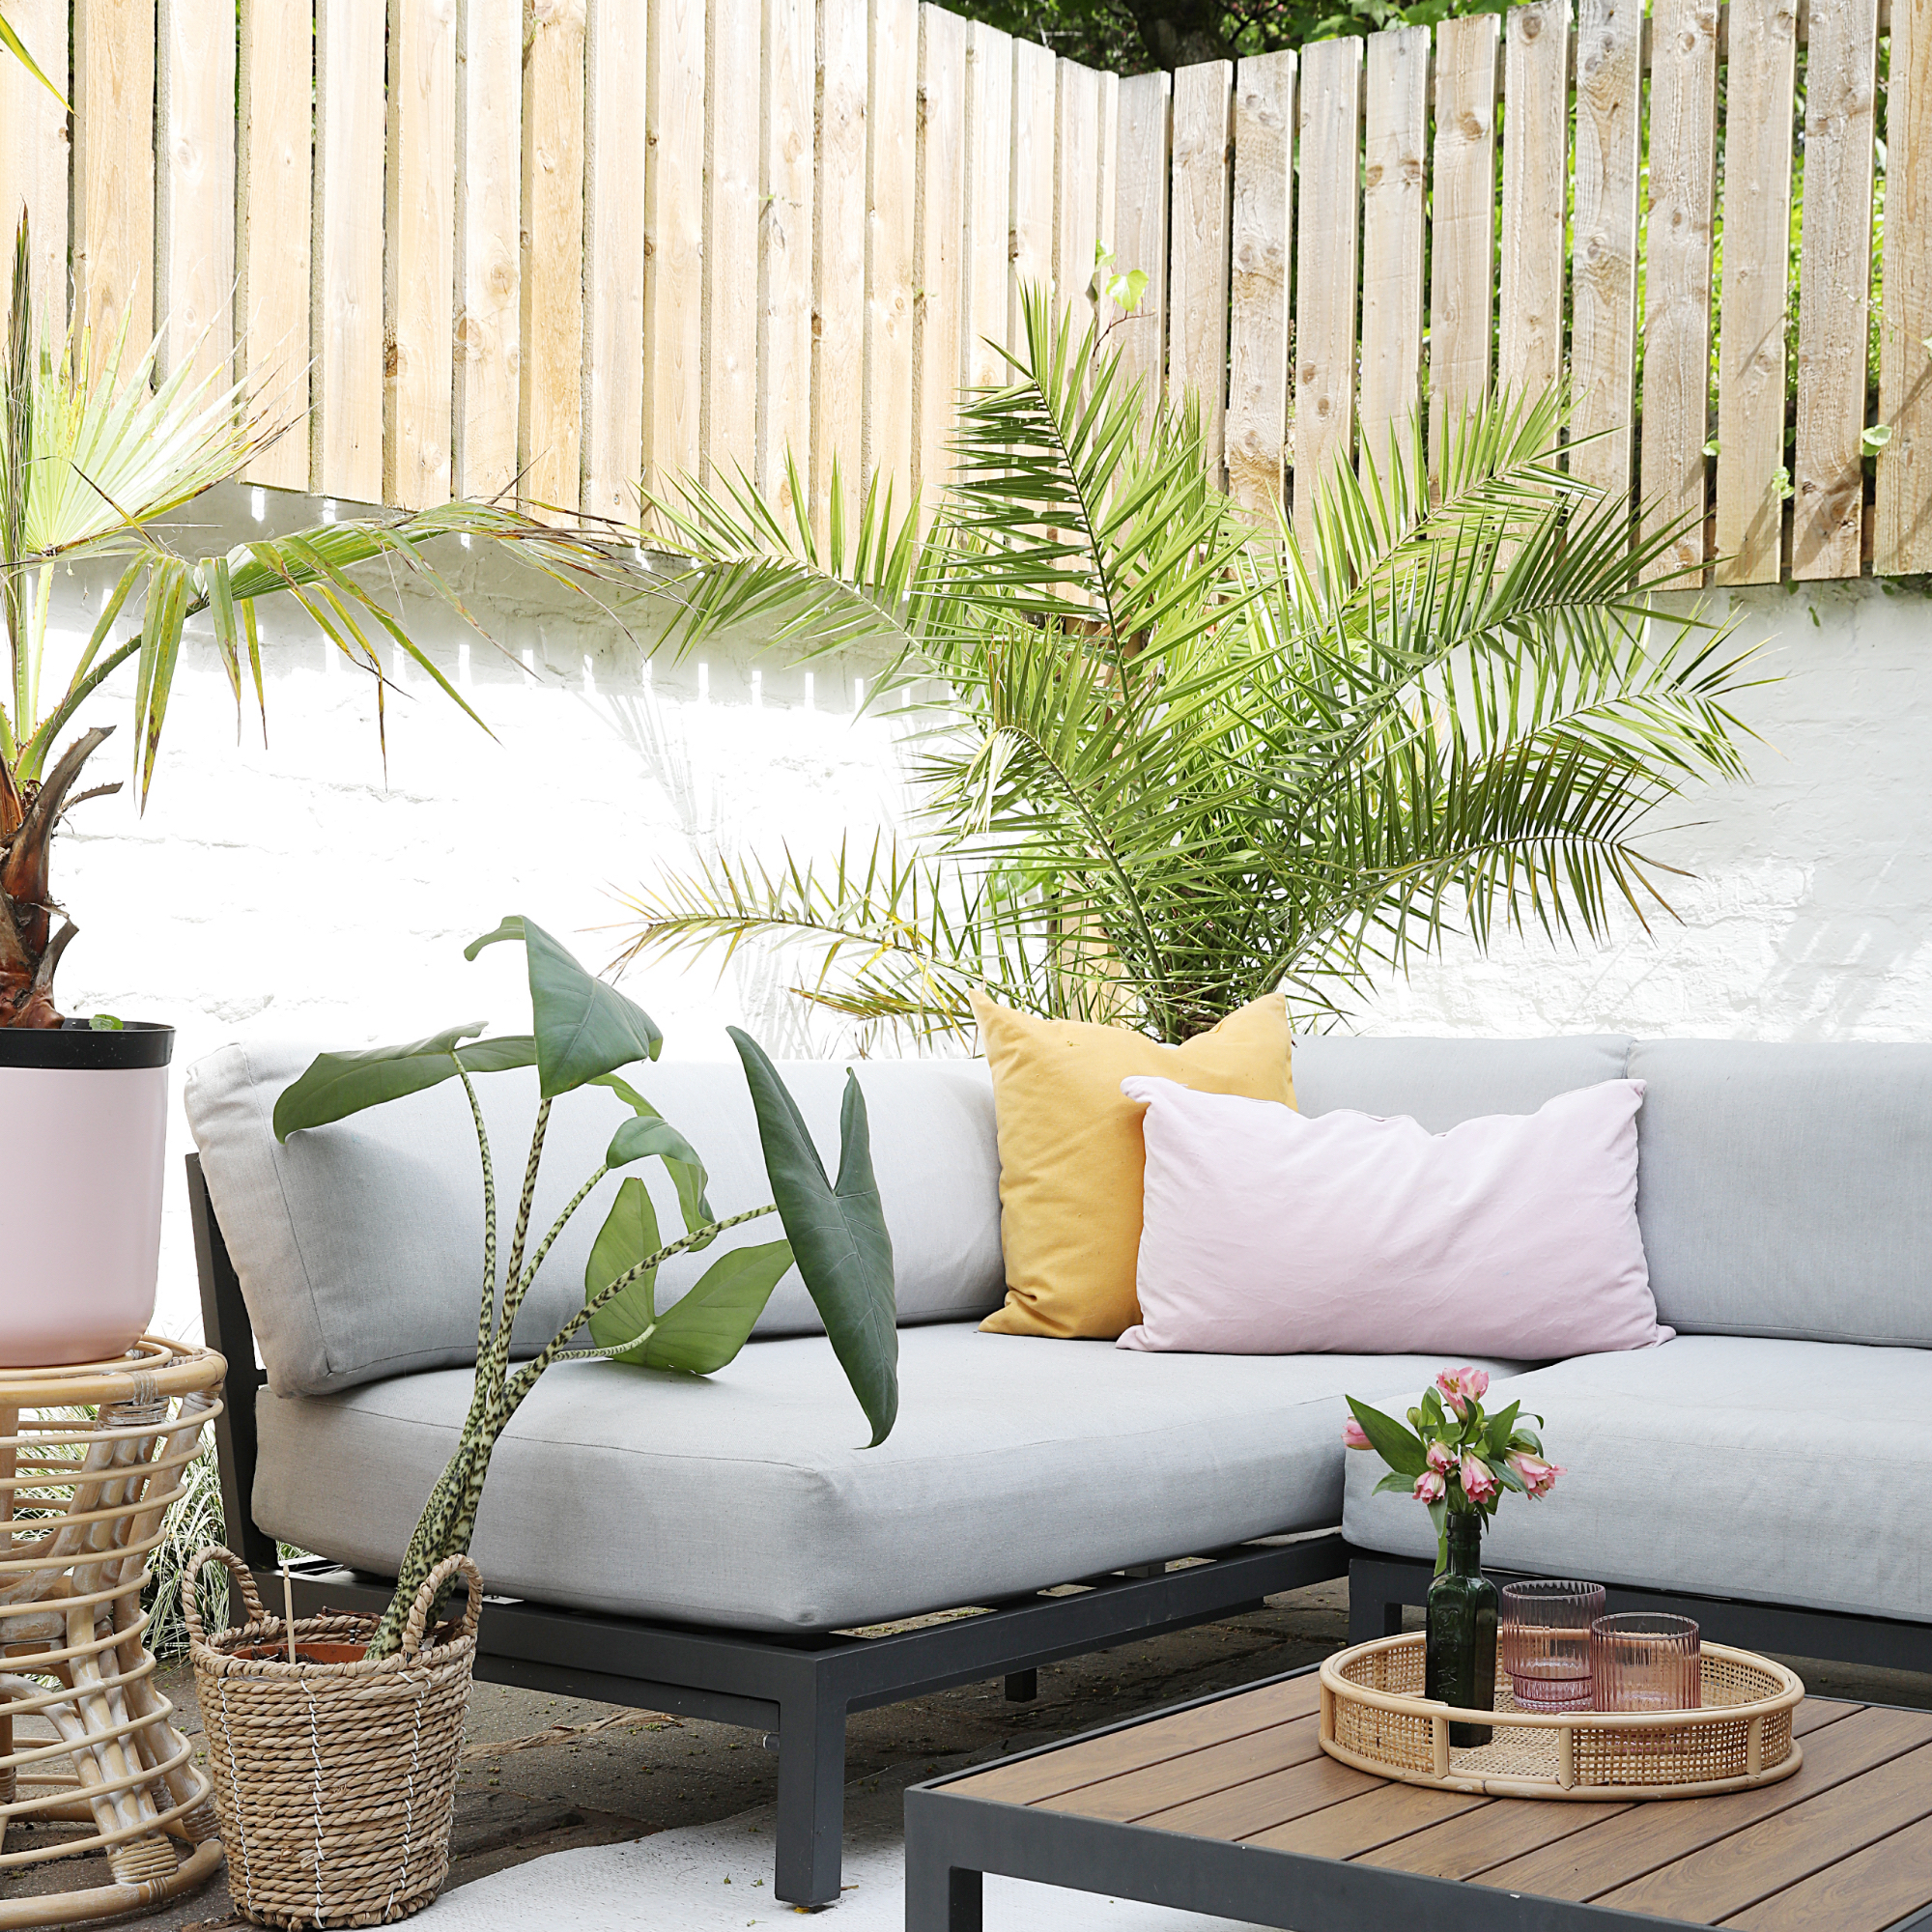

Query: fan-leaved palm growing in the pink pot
0,218,624,1028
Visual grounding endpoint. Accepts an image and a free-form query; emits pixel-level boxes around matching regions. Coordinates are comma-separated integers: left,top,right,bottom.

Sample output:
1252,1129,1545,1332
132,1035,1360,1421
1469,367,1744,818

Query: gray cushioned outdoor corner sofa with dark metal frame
187,1036,1932,1905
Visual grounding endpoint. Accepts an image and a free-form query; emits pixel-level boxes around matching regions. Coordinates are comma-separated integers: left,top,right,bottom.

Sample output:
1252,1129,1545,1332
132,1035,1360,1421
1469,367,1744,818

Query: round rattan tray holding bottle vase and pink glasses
1320,1633,1804,1799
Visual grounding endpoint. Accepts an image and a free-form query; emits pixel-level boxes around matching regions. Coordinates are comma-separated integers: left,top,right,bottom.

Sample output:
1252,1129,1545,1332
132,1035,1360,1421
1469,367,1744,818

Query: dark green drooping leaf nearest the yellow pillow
728,1026,898,1447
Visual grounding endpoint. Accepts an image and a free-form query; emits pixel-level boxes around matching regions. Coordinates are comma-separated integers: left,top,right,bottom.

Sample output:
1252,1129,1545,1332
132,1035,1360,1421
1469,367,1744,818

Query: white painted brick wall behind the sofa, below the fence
42,493,1932,1333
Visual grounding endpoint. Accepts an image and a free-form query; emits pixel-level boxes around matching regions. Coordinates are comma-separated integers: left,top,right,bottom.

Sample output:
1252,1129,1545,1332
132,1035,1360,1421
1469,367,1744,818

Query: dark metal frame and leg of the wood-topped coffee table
906,1663,1932,1932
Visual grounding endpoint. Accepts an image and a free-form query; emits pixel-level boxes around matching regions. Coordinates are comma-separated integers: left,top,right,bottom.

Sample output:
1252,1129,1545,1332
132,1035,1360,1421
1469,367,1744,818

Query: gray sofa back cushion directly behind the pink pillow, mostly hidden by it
1294,1034,1642,1128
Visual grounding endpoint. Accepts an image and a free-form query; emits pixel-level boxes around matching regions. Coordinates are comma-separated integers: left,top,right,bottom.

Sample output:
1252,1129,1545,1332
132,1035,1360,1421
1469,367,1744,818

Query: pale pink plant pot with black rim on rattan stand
0,1026,174,1368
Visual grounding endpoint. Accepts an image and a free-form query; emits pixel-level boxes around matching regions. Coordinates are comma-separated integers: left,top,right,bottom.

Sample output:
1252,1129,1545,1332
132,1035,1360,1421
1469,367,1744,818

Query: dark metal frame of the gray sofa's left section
187,1155,1349,1905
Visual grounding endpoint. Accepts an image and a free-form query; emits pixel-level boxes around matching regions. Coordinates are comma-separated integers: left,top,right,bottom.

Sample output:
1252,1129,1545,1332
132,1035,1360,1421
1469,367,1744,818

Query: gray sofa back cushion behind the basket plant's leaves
184,1045,1007,1395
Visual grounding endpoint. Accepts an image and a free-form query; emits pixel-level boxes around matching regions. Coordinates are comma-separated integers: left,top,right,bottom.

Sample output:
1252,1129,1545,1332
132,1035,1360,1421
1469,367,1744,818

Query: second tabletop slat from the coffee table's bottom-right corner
1594,1741,1932,1924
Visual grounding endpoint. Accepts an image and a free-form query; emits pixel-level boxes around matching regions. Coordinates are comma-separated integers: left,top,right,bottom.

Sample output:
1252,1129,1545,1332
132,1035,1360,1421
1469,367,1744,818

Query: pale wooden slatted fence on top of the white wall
0,0,1932,582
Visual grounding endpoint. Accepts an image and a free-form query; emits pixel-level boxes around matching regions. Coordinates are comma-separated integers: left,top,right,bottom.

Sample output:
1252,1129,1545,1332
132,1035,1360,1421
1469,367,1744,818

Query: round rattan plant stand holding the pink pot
0,1335,228,1932
